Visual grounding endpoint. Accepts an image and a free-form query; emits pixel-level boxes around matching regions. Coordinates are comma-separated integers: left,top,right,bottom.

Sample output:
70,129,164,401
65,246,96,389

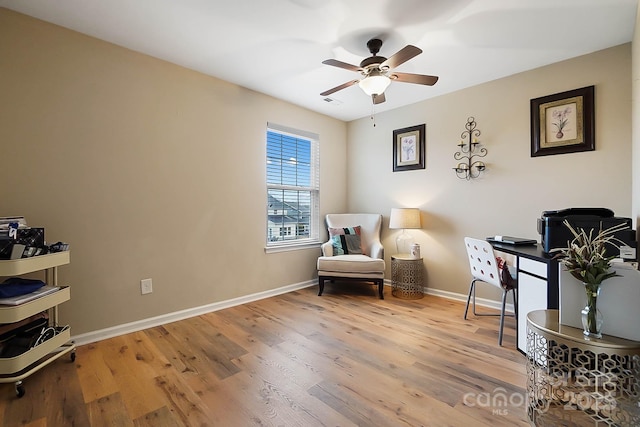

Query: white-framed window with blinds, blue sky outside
267,123,320,248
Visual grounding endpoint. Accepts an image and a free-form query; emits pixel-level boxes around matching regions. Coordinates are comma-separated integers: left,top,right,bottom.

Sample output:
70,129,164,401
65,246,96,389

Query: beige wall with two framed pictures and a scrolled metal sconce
348,44,632,296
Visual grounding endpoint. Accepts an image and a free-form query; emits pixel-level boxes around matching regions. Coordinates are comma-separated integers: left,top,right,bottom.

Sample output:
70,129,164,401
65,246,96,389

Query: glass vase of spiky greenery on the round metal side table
552,220,628,338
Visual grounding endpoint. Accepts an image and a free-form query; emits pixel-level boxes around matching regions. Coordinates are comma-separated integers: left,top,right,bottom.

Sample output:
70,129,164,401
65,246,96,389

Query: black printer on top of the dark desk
538,208,637,261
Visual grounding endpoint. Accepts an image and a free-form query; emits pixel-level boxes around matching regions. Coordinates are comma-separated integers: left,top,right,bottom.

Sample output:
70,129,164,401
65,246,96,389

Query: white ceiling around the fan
0,0,638,121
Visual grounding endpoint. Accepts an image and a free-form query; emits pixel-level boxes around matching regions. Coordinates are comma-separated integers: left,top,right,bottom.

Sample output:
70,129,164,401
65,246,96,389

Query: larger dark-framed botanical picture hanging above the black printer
531,86,596,157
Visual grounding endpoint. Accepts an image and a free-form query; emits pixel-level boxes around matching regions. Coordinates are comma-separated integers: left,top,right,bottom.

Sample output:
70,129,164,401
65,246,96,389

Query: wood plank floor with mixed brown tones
0,283,529,427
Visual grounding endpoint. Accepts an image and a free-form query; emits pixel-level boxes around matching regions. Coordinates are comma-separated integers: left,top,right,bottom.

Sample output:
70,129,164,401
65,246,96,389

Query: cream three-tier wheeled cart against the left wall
0,251,76,397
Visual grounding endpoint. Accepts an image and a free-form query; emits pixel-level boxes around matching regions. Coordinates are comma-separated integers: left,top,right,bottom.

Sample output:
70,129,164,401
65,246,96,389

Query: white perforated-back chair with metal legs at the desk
464,237,518,345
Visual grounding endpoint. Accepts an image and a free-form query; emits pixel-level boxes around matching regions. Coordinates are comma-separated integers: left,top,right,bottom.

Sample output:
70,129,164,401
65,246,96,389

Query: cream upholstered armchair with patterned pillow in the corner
318,214,385,299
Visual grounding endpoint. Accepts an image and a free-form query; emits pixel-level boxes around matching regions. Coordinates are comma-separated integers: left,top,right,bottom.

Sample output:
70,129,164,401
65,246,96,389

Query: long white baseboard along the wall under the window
71,280,318,345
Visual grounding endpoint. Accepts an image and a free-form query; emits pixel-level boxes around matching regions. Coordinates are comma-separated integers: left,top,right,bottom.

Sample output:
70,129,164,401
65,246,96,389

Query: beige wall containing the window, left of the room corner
0,8,346,335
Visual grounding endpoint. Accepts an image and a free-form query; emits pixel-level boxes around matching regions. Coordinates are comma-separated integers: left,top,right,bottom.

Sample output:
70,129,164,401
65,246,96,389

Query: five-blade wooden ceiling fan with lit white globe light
320,39,438,104
